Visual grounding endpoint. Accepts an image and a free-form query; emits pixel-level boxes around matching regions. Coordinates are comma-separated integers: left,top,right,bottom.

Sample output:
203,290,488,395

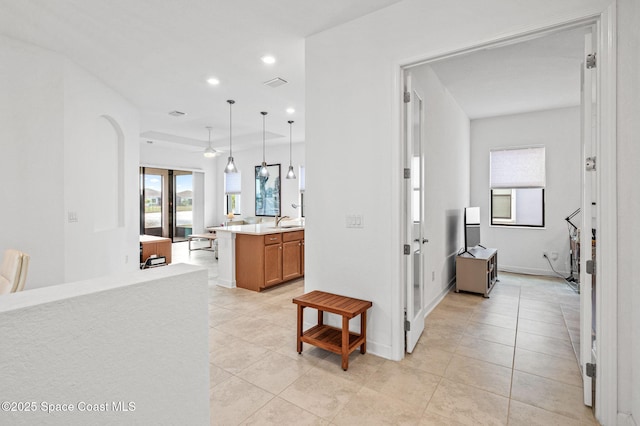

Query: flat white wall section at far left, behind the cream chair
0,36,64,289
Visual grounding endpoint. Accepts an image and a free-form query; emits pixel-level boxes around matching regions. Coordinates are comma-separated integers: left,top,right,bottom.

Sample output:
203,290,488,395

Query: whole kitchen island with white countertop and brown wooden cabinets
214,222,304,291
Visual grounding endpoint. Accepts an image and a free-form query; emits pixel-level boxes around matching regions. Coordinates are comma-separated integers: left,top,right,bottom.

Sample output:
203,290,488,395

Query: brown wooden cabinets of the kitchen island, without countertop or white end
236,231,304,291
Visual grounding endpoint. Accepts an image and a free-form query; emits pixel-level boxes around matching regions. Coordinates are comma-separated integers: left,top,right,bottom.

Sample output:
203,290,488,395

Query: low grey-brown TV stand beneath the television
456,246,498,297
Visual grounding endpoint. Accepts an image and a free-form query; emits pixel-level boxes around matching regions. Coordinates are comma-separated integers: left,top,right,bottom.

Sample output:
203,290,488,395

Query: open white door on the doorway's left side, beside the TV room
404,72,427,353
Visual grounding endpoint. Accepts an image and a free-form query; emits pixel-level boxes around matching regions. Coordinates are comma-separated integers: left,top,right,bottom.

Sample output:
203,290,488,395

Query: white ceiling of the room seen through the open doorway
430,28,586,119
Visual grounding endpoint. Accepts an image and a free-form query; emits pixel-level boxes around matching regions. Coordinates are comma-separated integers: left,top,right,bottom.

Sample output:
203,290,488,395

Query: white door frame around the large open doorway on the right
392,5,618,424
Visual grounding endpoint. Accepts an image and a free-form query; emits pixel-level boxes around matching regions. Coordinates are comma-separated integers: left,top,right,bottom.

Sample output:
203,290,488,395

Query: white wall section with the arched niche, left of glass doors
62,59,140,287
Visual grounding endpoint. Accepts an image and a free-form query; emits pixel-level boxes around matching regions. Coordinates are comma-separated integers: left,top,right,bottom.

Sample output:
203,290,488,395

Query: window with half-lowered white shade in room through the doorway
490,146,546,227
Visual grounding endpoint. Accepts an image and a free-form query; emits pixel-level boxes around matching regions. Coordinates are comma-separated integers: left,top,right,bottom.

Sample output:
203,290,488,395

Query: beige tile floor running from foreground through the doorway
174,243,597,426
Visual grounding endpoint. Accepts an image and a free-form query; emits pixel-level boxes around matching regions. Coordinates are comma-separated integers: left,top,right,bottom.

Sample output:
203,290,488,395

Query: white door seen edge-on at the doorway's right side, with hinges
580,29,598,406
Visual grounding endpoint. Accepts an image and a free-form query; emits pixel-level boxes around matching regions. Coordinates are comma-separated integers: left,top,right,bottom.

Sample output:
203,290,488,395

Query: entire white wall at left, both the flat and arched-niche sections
0,37,139,289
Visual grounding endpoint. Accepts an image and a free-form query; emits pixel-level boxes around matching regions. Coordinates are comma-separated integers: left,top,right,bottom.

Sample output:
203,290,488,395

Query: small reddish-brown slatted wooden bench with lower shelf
293,290,373,371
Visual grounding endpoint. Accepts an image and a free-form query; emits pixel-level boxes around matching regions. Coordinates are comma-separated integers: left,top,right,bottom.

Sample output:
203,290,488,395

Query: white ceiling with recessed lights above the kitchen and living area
0,0,400,151
